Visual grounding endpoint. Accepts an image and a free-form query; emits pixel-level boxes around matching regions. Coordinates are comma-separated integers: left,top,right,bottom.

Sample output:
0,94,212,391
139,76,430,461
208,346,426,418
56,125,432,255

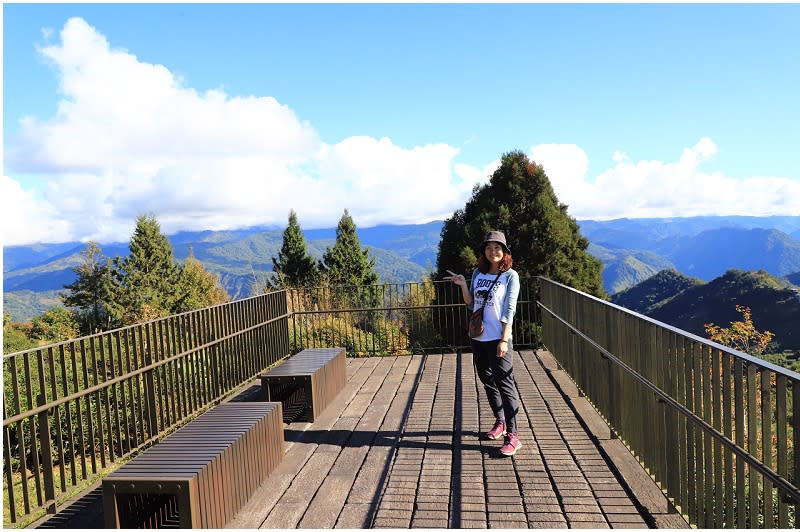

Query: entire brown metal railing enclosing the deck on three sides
12,278,800,528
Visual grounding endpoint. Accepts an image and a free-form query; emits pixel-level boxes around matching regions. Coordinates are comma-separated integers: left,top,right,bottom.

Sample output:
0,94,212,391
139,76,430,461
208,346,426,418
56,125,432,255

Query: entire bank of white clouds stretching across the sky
0,18,800,245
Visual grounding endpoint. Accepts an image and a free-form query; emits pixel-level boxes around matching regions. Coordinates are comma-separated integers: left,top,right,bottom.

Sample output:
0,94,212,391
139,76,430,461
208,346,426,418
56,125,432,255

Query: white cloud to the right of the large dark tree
531,137,800,219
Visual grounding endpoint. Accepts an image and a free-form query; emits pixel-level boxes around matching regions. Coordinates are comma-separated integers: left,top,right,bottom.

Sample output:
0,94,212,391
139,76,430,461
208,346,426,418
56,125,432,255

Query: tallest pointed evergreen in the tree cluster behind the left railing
110,215,179,325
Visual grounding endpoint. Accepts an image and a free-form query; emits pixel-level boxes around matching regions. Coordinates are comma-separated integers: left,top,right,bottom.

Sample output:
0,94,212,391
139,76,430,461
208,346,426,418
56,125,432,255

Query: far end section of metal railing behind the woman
288,278,539,356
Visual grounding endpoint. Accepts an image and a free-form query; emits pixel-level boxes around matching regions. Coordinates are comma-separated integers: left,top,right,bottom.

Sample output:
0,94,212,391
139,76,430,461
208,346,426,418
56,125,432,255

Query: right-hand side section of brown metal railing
539,279,800,528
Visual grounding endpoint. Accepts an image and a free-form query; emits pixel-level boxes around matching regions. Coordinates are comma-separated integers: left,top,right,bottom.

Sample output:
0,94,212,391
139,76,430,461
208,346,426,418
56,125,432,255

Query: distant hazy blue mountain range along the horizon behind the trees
3,216,800,321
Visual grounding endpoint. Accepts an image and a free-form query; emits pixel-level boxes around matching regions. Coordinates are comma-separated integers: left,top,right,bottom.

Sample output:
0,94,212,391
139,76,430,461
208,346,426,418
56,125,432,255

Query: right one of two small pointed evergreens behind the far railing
319,209,378,285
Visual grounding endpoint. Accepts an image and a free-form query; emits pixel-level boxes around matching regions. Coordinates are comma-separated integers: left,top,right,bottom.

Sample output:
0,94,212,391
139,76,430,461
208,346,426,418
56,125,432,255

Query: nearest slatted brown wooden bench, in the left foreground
103,402,283,528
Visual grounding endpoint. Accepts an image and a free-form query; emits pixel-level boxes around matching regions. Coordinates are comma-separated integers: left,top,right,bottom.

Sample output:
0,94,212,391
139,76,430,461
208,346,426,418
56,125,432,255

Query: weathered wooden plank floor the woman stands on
228,351,681,528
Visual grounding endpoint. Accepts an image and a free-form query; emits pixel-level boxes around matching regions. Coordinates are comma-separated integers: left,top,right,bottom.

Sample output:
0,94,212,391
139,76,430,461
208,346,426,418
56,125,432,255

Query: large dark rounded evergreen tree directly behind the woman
437,151,606,297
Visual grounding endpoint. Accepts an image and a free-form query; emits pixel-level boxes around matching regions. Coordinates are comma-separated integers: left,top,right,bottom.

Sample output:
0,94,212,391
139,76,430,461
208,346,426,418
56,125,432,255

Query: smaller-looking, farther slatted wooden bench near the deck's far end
260,347,347,422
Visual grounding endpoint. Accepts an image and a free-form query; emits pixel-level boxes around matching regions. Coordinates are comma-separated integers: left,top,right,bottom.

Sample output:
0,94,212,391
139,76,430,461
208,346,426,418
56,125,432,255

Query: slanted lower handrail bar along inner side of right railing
537,302,800,503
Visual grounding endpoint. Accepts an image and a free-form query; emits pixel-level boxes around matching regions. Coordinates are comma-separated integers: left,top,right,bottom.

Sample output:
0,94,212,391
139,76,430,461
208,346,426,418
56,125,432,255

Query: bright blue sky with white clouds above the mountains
2,4,800,245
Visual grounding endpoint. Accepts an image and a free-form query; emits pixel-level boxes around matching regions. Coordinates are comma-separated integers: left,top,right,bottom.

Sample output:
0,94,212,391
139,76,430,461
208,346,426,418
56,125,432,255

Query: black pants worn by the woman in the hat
472,340,519,432
